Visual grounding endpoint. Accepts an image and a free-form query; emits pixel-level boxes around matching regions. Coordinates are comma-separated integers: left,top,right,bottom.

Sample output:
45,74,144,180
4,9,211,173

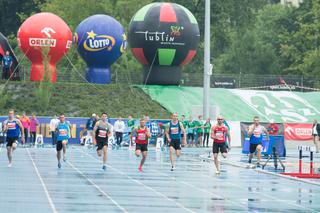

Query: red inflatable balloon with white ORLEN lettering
18,13,72,82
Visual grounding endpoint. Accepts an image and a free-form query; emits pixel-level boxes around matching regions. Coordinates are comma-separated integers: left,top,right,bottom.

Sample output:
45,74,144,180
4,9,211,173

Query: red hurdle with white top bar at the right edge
280,146,320,179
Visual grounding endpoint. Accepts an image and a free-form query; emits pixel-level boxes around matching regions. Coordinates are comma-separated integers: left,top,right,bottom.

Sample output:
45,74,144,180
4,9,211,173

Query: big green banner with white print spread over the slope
139,85,320,123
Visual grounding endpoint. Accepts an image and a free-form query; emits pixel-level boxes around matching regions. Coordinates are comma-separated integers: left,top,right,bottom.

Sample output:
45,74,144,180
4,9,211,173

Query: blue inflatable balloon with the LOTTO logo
74,15,127,84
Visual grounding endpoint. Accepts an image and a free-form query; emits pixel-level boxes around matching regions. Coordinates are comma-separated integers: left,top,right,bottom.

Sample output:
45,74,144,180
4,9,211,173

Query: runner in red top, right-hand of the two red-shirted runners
211,116,231,174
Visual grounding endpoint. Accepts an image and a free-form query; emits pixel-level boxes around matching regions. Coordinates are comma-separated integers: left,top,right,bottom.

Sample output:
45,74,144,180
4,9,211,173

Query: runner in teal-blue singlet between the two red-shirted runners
166,113,186,171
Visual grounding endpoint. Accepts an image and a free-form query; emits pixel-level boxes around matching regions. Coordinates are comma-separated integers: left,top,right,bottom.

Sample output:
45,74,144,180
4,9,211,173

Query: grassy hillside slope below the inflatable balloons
0,82,169,118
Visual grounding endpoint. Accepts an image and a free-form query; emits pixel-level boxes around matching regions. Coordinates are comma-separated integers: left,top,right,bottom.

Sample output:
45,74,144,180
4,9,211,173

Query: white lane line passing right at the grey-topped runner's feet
76,148,196,213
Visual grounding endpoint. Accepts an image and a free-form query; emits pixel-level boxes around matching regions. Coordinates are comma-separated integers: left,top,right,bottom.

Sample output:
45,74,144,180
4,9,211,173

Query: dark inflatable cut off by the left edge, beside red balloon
0,32,20,80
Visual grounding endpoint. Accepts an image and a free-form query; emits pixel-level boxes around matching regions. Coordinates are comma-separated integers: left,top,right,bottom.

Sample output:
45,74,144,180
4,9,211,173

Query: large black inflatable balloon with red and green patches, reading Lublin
128,3,200,85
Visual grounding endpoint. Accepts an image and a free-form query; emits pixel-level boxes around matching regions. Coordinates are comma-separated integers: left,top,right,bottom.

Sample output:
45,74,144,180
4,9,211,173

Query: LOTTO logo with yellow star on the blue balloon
83,31,116,52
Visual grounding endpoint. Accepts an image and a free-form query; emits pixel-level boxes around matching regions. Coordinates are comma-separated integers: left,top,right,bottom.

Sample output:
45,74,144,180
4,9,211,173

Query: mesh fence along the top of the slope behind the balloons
11,67,320,91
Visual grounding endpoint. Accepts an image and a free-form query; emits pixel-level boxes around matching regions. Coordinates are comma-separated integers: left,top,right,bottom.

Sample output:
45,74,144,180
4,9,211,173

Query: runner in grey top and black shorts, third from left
92,112,111,170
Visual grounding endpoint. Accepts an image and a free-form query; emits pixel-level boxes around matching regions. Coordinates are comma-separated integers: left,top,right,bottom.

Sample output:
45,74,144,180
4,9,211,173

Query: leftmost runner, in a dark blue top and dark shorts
3,109,24,167
